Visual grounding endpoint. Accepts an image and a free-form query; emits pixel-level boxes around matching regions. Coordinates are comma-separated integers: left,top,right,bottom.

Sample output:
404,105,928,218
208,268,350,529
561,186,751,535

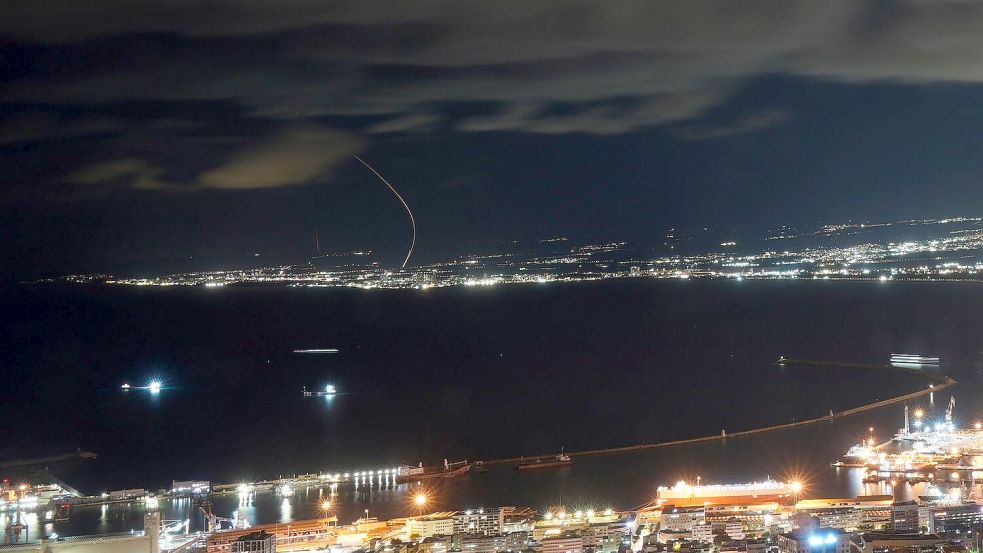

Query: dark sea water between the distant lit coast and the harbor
0,280,983,535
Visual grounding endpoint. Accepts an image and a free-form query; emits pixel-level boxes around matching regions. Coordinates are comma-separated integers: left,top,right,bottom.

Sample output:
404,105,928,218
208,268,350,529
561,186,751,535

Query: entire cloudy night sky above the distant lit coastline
0,0,983,278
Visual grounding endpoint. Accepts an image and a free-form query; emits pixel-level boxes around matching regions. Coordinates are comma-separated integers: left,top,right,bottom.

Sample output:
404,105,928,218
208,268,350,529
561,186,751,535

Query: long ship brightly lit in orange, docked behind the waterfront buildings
656,480,802,507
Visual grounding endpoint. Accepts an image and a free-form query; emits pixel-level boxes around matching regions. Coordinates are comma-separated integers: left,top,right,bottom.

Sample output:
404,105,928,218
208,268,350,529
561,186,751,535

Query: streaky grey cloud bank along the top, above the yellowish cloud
0,0,983,149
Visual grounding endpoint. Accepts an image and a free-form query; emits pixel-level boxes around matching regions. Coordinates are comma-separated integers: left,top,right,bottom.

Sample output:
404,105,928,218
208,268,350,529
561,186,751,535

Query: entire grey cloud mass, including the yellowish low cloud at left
0,0,983,207
